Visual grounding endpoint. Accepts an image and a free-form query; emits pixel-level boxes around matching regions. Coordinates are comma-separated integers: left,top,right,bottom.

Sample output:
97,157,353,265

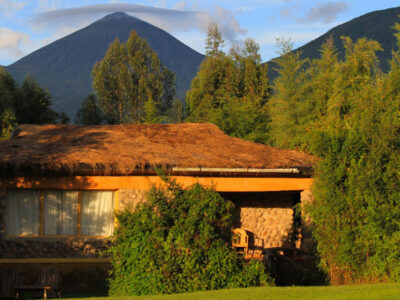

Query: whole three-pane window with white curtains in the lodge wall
6,189,114,236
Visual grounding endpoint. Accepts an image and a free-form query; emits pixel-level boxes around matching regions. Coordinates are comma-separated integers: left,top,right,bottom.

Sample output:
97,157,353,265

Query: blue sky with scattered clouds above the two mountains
0,0,400,65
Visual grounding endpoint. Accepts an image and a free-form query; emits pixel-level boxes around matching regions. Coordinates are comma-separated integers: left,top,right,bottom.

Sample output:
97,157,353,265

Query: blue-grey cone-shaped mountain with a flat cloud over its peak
6,13,204,116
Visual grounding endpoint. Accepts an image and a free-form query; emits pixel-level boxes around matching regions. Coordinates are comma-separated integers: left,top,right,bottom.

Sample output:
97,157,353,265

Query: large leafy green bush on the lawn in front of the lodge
109,179,270,295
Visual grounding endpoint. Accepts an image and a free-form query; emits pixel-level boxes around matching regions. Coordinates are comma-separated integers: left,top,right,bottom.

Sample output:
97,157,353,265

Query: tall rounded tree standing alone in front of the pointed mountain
92,31,175,124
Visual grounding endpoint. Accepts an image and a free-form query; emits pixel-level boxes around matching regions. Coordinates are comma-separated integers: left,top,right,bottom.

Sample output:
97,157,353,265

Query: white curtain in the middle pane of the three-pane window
44,190,78,235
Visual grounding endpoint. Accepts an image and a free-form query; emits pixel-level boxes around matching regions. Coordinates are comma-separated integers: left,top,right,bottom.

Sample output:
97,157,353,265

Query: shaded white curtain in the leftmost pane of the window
6,190,40,235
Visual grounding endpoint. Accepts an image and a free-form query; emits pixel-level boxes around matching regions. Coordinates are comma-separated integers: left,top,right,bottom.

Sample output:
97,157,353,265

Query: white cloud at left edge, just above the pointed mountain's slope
0,27,34,60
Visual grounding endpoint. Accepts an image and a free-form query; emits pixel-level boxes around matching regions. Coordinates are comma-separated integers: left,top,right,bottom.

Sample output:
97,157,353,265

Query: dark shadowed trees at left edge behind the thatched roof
0,67,69,136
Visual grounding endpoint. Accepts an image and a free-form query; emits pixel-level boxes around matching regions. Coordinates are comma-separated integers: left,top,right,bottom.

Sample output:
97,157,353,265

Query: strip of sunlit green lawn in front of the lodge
65,283,400,300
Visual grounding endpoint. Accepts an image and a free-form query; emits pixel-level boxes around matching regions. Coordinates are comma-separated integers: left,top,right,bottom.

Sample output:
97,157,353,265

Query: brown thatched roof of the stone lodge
0,124,313,176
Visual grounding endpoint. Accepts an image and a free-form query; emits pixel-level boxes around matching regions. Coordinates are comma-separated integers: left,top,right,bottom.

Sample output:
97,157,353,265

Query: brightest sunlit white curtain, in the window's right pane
81,191,114,236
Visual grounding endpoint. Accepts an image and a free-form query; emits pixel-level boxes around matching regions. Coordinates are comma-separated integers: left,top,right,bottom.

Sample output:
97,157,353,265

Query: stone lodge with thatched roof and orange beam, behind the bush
0,123,314,289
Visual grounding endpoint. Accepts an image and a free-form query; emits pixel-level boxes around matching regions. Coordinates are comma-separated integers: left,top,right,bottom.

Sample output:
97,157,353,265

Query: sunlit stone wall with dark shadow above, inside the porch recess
221,192,299,248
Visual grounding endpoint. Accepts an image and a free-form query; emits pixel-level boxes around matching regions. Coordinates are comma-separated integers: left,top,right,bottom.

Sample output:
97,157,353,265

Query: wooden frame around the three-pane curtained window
4,188,119,239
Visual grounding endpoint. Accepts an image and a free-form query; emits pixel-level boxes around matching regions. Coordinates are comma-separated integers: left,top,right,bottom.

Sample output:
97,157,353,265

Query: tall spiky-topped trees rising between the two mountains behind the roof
186,24,269,142
